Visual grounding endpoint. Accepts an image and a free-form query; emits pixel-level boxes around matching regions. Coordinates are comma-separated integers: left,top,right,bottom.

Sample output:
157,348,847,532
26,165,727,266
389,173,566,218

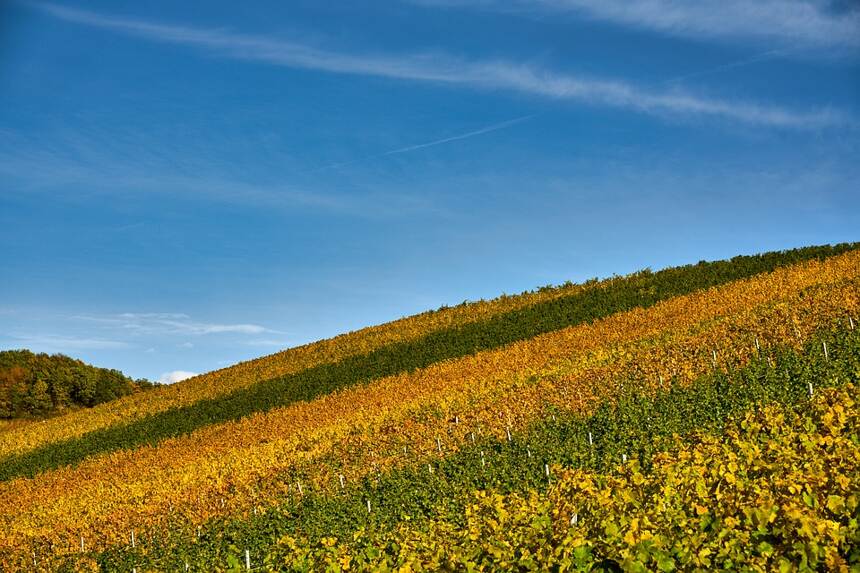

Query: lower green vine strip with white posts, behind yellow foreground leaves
85,329,860,571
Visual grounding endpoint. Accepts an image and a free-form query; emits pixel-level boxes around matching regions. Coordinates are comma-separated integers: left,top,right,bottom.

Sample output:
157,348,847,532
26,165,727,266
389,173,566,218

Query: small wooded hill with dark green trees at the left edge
0,350,153,419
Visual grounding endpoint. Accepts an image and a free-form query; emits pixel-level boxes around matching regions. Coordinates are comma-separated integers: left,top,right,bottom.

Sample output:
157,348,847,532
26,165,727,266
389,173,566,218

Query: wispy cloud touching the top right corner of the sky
414,0,860,49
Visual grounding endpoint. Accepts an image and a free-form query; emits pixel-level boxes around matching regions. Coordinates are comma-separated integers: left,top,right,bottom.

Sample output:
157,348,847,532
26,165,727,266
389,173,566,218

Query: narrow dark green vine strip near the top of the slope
0,240,860,480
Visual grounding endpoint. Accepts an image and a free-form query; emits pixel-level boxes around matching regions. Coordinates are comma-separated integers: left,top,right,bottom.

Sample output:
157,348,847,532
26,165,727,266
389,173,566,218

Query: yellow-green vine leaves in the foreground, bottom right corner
265,384,860,573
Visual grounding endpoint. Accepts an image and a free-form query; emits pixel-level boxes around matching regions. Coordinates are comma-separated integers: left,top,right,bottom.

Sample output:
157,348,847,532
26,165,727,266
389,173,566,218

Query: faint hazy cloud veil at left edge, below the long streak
0,126,441,217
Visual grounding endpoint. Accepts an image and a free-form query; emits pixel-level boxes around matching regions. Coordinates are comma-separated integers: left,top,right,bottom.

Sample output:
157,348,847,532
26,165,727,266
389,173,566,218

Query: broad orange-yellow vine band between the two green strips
0,253,860,559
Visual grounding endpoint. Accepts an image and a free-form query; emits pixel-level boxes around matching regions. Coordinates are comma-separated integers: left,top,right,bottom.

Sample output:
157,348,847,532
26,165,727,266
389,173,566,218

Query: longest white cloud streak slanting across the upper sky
31,0,853,129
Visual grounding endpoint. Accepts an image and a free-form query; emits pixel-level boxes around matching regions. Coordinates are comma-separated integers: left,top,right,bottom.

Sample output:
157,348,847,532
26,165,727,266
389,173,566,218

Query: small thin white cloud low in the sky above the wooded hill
72,312,278,336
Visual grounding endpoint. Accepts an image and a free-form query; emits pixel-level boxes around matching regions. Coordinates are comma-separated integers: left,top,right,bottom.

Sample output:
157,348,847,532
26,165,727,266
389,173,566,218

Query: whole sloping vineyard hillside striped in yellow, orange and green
0,244,860,571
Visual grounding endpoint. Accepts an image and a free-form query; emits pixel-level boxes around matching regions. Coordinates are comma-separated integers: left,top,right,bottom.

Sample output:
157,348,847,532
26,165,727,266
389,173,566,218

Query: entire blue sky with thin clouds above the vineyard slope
0,0,860,379
